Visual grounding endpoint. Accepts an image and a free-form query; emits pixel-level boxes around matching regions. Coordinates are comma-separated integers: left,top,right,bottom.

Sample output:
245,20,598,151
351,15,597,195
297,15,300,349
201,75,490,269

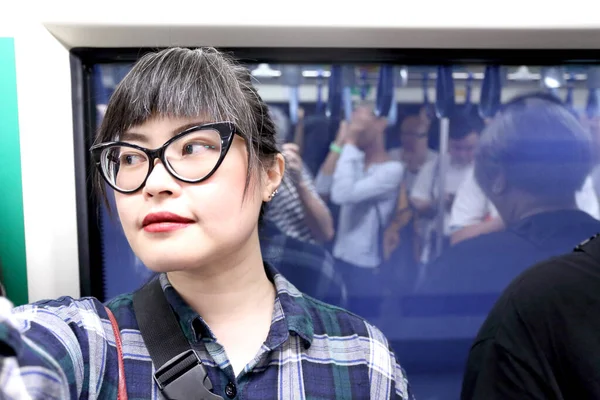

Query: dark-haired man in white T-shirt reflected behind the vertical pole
410,115,483,262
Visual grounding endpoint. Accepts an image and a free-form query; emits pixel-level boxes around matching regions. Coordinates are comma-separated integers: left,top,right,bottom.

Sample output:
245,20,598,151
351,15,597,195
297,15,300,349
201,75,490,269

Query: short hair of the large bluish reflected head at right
475,93,592,198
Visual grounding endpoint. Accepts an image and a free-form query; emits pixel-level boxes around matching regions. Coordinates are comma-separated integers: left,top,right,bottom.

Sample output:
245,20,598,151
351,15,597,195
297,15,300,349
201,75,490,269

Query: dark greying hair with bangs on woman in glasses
94,47,279,219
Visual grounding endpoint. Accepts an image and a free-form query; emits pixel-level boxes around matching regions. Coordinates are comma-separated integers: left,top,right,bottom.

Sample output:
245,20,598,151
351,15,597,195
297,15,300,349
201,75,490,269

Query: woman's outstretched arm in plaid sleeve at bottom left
0,298,117,399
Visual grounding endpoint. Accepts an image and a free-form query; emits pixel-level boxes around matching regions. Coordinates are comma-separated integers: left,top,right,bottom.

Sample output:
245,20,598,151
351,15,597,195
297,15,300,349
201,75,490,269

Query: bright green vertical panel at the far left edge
0,37,27,305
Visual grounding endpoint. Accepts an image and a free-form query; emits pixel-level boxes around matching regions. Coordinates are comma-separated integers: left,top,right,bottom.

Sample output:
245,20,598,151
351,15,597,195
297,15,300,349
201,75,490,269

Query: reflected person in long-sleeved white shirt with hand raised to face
315,105,404,317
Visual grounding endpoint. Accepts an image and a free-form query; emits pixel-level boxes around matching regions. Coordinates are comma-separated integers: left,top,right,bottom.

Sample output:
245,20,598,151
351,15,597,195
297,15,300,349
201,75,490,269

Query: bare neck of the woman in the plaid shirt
168,237,275,327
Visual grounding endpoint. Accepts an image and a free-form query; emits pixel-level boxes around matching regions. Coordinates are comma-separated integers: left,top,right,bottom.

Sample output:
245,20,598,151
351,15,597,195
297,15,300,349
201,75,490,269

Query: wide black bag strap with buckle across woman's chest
133,278,223,400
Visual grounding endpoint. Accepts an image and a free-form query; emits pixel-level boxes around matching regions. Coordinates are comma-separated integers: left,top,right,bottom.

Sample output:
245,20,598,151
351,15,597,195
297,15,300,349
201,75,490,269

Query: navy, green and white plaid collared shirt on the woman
0,267,412,400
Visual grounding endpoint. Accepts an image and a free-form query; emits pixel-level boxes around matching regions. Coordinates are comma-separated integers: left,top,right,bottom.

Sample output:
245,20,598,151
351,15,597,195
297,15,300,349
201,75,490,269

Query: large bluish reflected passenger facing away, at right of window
421,94,600,304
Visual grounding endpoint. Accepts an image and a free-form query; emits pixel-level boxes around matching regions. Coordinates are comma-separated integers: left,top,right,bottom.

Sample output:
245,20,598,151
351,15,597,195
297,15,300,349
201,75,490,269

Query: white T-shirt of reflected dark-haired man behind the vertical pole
410,160,473,235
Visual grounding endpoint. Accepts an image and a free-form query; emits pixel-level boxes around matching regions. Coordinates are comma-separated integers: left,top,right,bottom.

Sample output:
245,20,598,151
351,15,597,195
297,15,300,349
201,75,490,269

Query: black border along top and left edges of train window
70,44,600,301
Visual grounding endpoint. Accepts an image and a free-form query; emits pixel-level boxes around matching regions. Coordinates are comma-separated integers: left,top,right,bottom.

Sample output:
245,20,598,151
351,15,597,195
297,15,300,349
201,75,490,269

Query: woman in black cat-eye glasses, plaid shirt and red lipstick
0,48,410,399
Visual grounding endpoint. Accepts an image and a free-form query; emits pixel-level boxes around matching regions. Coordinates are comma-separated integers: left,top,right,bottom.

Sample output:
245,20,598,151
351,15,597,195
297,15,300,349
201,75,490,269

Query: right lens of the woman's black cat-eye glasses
165,129,221,180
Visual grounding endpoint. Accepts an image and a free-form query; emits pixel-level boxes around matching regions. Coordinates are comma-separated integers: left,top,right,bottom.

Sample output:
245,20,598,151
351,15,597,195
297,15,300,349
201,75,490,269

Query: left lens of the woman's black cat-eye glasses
101,146,149,191
